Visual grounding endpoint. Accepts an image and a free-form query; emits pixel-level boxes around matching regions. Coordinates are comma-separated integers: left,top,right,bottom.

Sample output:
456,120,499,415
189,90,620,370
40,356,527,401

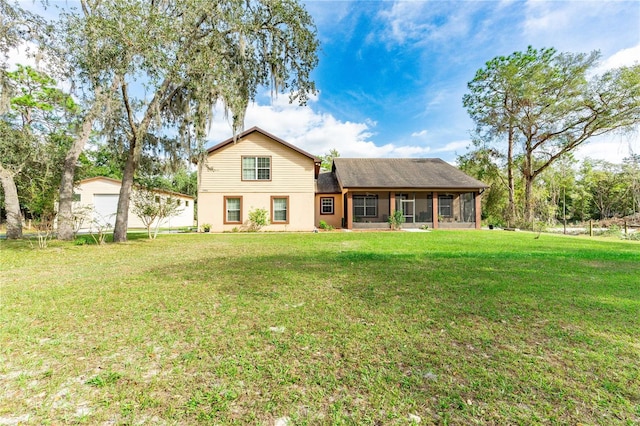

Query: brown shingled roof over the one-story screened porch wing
333,158,488,190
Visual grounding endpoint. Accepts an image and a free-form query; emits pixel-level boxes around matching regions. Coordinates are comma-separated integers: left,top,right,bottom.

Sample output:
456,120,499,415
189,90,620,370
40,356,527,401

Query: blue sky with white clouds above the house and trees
210,0,640,162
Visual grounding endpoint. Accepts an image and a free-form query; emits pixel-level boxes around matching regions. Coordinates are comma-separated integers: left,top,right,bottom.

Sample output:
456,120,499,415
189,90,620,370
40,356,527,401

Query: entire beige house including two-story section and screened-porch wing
198,127,487,232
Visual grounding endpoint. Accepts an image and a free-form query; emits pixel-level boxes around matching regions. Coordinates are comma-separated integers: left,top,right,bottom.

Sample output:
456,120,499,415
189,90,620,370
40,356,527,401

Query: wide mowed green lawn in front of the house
0,231,640,425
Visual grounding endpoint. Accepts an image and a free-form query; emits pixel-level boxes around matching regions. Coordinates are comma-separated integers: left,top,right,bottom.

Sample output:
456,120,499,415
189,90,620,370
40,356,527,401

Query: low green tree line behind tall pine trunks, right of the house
457,148,640,228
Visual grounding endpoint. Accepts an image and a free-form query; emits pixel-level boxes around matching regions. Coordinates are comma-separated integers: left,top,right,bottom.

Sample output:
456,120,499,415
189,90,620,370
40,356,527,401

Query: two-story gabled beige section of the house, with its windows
198,127,320,232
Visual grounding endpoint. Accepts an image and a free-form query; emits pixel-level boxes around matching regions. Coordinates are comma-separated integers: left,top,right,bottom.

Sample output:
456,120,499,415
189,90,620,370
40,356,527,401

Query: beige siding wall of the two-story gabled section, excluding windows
198,132,315,232
